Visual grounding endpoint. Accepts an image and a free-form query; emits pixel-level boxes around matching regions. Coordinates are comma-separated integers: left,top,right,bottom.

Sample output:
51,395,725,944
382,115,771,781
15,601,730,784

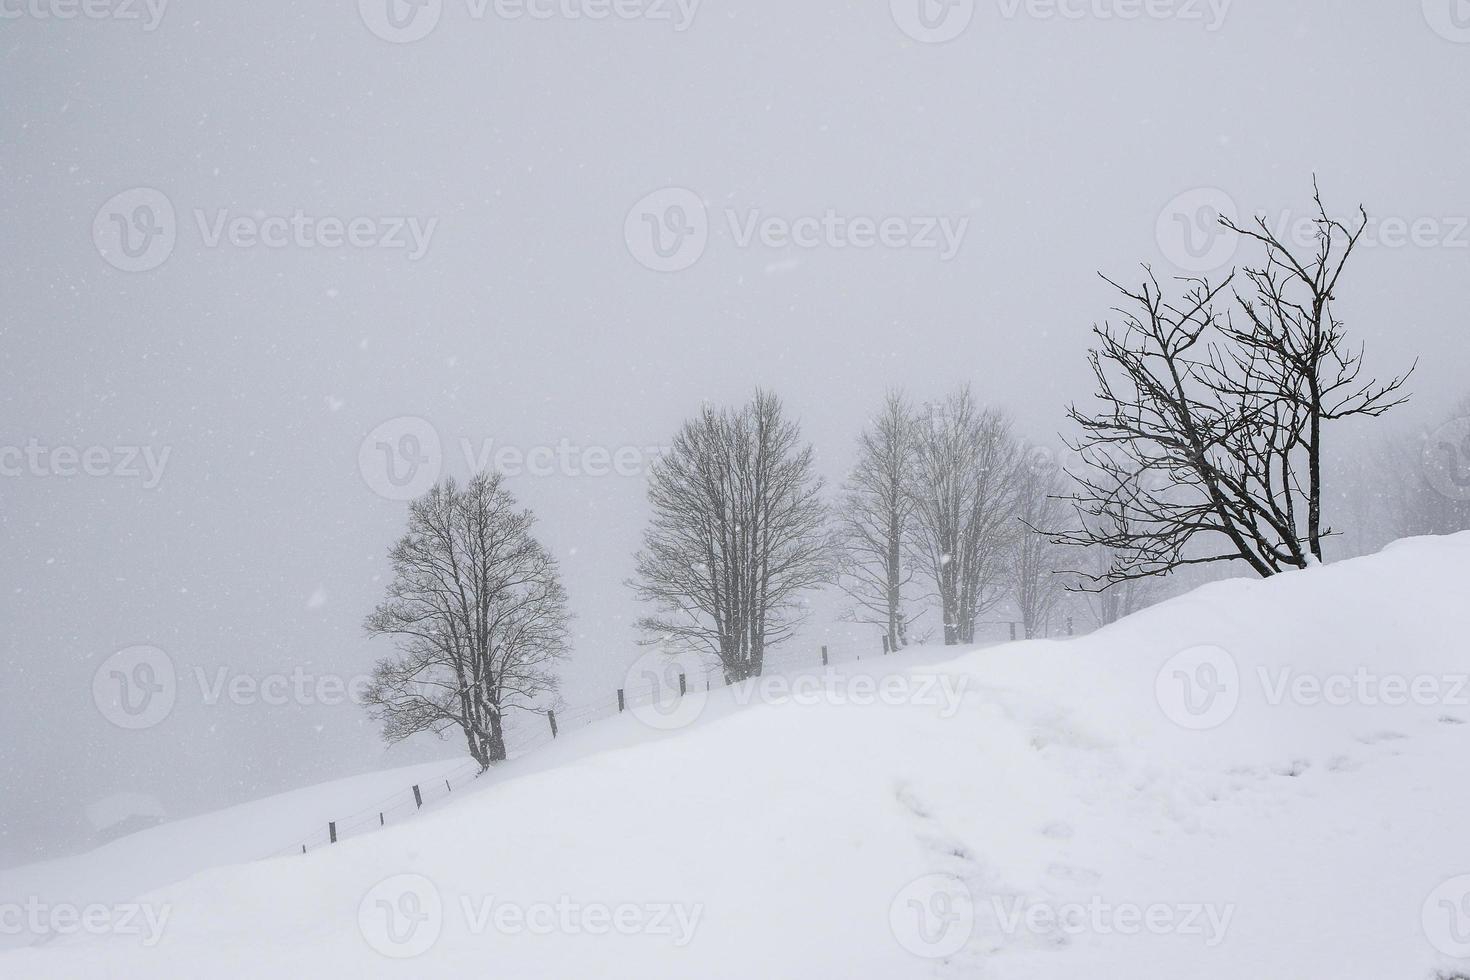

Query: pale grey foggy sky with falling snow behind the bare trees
0,0,1470,865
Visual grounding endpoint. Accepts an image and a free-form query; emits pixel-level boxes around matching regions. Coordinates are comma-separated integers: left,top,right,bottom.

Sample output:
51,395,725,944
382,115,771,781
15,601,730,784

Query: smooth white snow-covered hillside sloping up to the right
0,535,1470,980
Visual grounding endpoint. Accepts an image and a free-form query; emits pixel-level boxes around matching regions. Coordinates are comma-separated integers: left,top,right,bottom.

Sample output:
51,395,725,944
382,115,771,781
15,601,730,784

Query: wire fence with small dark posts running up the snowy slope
268,620,1019,857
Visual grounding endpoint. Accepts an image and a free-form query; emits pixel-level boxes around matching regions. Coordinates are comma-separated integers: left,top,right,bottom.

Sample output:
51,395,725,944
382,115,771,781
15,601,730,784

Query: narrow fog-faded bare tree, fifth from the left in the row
1011,447,1072,639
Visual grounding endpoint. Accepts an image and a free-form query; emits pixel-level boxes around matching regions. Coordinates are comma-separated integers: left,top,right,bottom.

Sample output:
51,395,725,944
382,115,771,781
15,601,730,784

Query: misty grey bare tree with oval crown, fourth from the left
910,386,1019,645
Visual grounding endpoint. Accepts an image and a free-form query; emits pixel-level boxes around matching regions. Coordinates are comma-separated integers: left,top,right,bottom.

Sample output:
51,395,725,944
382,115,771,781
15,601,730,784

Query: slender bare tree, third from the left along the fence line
836,392,917,649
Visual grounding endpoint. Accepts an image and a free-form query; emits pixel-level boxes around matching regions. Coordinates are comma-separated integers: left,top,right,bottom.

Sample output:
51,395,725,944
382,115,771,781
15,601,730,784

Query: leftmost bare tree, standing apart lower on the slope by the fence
366,473,569,768
